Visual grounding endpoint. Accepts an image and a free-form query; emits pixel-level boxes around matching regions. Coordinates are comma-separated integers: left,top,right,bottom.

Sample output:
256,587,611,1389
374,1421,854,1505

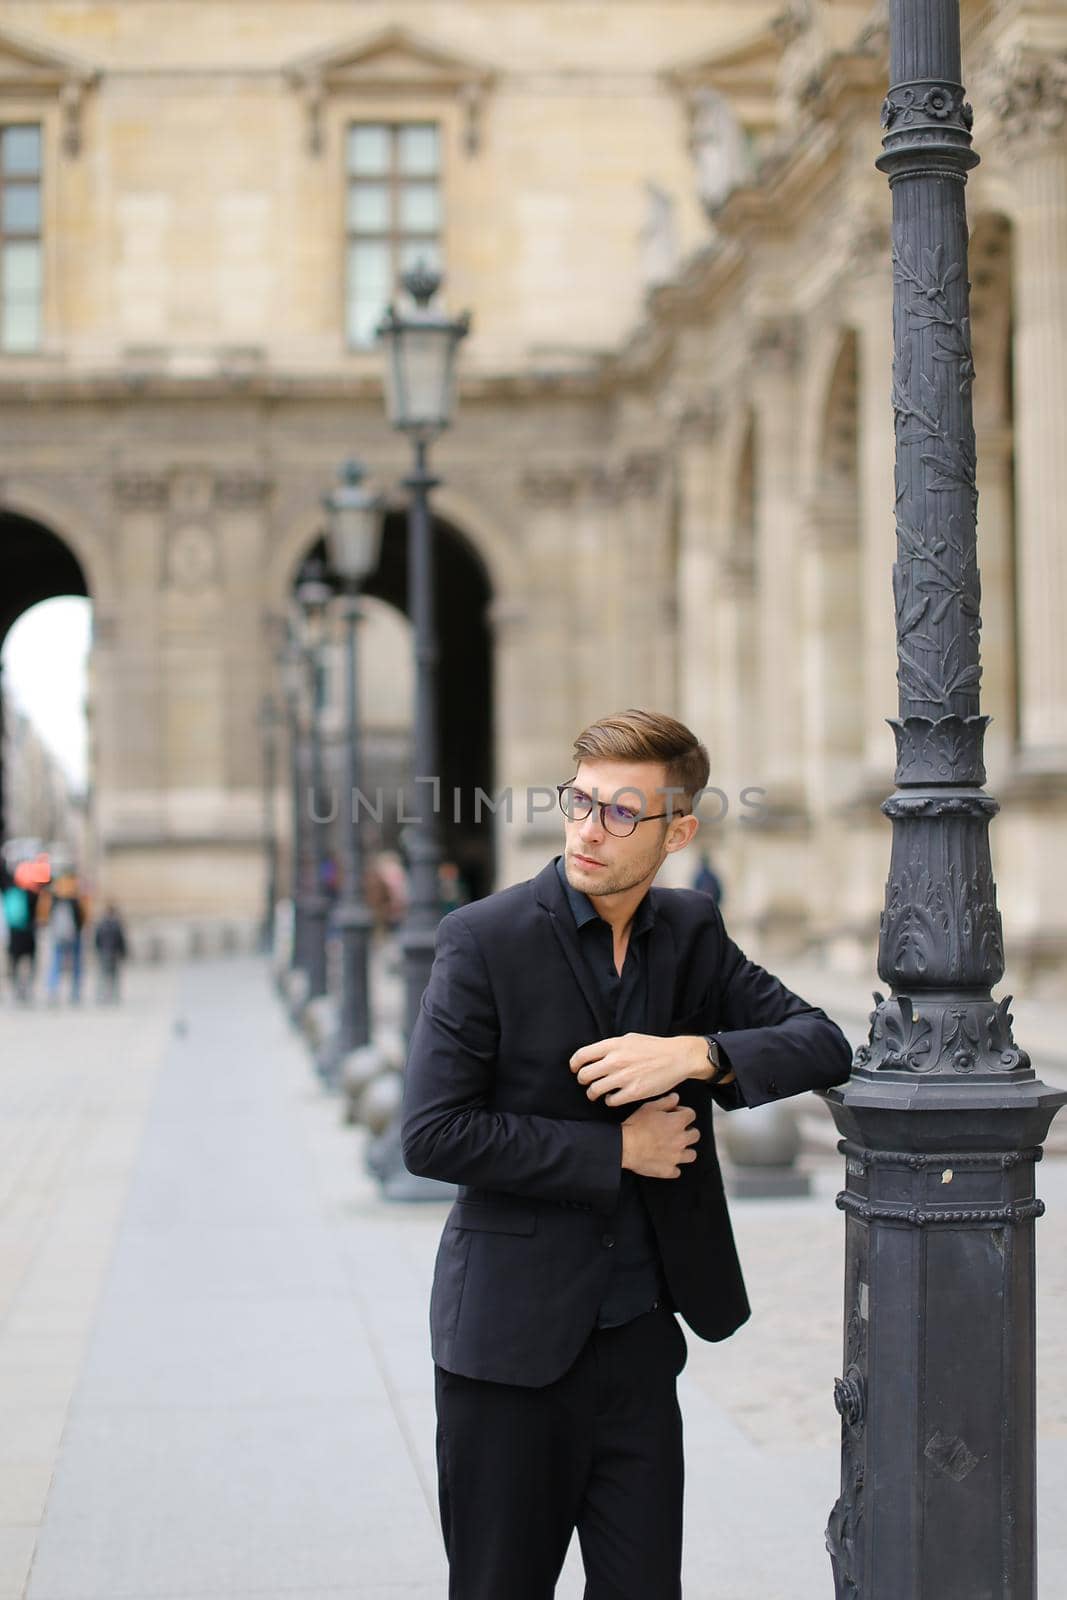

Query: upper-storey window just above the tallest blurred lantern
346,122,442,346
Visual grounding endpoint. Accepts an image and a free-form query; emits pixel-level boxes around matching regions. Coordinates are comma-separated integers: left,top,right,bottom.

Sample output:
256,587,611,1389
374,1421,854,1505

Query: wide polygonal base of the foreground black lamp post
825,1074,1067,1600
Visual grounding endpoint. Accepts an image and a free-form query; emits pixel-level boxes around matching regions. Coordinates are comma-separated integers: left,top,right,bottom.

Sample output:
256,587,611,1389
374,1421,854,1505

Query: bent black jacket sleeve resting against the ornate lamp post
712,917,853,1110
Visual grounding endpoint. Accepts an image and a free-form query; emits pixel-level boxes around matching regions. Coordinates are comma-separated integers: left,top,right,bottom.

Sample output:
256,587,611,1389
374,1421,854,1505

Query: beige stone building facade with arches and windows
0,0,1067,982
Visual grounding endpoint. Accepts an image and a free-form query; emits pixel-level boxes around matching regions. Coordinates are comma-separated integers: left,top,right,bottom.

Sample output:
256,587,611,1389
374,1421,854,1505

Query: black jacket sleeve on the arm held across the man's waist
402,914,622,1213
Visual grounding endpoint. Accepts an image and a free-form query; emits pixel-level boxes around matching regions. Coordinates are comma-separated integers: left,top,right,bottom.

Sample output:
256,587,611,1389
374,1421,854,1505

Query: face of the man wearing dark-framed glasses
563,762,688,896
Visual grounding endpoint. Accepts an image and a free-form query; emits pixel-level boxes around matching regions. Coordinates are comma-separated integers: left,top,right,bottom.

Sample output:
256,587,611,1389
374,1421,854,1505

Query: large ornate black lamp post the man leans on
827,0,1067,1600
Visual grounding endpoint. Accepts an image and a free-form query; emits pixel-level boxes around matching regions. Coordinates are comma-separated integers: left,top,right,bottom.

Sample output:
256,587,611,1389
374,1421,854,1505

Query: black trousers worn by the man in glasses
437,1307,686,1600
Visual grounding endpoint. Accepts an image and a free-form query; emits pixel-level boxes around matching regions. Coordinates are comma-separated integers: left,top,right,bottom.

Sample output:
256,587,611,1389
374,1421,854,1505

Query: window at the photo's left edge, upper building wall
0,123,42,354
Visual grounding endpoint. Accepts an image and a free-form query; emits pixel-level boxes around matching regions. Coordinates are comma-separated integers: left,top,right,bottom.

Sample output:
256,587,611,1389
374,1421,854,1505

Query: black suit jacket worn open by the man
403,862,849,1387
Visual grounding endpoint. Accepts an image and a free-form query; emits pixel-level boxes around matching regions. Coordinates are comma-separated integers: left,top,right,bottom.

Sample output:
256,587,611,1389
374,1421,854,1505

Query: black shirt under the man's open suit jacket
555,856,664,1328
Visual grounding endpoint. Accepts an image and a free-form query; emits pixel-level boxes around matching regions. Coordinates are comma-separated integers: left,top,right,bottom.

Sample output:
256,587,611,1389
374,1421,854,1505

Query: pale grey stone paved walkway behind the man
0,960,1067,1600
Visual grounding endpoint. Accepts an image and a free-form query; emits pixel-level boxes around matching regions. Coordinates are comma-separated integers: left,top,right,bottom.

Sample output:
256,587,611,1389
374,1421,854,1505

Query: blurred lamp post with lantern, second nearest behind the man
323,461,384,1075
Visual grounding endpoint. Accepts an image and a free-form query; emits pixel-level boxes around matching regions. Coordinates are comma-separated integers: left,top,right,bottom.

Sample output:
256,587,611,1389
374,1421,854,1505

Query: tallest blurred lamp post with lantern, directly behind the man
378,266,470,1037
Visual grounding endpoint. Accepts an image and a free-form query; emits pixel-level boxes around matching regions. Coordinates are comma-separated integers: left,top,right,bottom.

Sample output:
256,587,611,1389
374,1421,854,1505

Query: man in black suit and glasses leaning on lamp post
403,710,849,1600
